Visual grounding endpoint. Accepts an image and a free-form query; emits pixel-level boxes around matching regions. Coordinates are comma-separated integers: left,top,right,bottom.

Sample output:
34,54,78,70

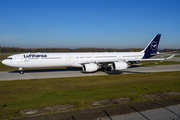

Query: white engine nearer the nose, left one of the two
82,63,99,72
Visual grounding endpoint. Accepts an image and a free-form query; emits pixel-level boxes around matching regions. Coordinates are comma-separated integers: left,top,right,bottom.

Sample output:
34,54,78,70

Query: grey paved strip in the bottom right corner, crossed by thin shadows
101,105,180,120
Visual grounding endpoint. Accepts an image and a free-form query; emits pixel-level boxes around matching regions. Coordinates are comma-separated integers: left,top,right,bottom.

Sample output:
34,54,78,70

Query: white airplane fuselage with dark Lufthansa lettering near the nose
2,52,144,68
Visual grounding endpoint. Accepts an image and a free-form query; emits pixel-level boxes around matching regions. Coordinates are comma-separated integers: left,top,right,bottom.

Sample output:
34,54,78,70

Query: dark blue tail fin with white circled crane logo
142,34,161,58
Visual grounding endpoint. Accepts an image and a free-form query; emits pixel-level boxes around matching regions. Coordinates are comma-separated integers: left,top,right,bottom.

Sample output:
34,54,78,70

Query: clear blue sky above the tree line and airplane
0,0,180,49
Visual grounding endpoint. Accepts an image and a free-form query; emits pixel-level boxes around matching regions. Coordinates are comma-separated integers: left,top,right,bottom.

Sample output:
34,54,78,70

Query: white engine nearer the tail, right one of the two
111,61,128,70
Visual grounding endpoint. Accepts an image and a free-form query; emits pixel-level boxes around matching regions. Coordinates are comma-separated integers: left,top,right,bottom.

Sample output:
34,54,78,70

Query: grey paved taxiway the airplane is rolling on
0,65,180,81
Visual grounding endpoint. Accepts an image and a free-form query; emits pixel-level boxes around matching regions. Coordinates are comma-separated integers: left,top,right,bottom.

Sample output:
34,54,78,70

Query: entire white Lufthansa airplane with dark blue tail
2,34,175,74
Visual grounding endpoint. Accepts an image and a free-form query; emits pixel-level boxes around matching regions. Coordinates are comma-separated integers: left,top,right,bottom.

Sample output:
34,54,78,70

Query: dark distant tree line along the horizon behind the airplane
0,46,180,52
